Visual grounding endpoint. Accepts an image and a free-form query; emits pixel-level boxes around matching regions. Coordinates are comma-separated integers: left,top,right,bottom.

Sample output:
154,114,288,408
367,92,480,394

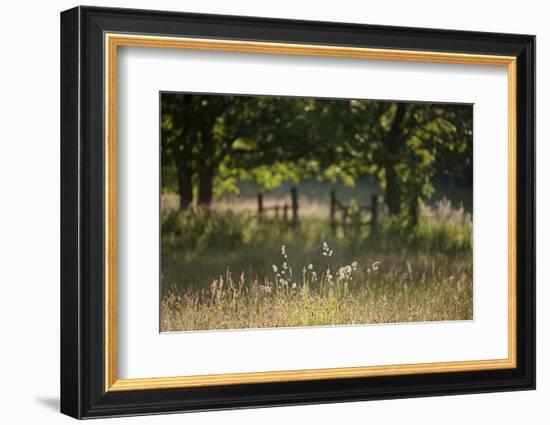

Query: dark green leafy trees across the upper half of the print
161,93,473,225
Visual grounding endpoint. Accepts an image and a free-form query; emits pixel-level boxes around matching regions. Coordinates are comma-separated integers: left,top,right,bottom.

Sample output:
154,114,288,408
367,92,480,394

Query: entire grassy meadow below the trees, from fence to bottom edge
161,195,473,332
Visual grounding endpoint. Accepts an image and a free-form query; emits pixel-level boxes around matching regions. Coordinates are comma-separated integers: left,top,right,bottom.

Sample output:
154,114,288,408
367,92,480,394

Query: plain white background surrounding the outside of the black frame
0,0,550,425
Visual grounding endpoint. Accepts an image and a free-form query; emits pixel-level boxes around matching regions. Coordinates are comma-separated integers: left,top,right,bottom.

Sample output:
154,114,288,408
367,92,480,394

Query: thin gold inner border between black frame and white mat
104,33,517,391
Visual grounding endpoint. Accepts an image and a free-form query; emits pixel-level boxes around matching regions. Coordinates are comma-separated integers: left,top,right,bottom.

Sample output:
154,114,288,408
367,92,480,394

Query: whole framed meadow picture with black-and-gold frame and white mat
61,7,535,418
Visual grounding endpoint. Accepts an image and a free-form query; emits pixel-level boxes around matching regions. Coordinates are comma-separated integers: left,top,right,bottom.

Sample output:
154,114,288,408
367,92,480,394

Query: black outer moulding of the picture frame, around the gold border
61,7,535,418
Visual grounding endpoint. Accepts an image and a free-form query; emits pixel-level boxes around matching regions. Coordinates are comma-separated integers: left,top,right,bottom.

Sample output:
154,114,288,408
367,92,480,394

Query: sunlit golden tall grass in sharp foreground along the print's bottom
161,243,473,331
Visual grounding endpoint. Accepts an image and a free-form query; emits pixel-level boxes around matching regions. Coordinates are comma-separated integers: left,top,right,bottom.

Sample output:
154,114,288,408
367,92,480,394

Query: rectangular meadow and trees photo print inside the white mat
160,92,473,332
